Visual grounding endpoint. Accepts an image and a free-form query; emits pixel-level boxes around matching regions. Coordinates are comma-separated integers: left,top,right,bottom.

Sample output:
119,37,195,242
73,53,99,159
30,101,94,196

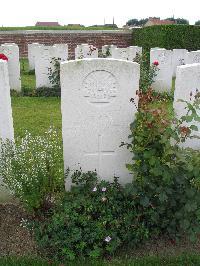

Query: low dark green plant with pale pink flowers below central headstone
33,171,148,261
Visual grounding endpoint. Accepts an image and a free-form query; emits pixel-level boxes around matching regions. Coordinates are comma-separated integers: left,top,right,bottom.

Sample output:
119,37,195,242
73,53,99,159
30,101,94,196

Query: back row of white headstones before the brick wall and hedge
0,43,200,95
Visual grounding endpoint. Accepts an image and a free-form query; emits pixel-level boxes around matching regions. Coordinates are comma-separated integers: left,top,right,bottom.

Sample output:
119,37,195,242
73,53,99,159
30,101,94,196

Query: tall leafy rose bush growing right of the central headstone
127,90,200,240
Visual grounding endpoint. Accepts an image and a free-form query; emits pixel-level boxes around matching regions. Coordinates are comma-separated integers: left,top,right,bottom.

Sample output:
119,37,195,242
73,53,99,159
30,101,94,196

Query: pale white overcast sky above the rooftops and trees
0,0,200,27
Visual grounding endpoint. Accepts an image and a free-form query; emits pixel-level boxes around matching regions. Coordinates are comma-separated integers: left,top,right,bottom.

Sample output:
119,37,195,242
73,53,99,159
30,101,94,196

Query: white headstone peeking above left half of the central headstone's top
75,43,98,59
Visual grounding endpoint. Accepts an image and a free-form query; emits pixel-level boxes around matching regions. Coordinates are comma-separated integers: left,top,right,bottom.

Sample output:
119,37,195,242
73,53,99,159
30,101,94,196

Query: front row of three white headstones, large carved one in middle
0,55,200,188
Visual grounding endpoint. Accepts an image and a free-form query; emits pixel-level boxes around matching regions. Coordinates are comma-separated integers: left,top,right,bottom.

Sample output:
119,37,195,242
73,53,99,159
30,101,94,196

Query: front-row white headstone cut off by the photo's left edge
0,60,14,141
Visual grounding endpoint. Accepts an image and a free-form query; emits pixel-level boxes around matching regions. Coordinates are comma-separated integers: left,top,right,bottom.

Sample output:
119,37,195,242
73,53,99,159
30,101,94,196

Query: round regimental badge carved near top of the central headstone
83,70,117,103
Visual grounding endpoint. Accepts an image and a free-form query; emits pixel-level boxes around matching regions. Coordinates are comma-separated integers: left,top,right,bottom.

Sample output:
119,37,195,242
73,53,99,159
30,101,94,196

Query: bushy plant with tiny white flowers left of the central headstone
0,128,63,213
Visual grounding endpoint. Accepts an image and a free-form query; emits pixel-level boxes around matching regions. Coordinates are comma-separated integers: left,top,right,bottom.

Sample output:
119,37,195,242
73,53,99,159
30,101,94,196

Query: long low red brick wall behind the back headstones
0,30,132,59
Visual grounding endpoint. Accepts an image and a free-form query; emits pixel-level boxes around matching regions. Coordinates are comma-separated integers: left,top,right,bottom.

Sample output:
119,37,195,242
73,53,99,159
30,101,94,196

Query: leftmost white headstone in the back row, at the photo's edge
0,43,21,91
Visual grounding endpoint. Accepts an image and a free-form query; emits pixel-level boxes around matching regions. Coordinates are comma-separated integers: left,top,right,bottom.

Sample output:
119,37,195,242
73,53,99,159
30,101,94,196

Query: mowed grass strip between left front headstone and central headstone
12,97,62,138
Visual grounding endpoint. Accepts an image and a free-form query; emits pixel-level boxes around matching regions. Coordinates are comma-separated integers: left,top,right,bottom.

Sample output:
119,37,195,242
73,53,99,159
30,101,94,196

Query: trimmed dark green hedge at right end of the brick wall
133,25,200,51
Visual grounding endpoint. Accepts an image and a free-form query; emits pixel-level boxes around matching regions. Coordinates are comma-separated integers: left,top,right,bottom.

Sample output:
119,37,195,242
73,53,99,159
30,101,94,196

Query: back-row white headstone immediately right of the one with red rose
172,49,188,77
